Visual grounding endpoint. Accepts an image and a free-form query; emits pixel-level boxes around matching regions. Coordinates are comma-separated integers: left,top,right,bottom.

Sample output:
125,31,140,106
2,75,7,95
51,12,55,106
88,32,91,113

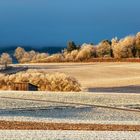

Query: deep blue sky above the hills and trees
0,0,140,46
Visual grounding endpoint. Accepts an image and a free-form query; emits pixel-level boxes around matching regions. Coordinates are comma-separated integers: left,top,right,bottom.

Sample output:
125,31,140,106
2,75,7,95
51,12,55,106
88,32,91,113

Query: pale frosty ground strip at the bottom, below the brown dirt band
0,130,140,140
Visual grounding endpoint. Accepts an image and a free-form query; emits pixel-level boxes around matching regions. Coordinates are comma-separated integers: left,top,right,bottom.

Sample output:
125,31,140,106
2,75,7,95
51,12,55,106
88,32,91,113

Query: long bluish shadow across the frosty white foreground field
0,106,94,119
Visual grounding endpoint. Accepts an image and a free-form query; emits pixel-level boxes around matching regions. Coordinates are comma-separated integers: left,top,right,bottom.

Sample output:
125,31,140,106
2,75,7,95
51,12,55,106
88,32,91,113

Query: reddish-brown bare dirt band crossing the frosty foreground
0,121,140,131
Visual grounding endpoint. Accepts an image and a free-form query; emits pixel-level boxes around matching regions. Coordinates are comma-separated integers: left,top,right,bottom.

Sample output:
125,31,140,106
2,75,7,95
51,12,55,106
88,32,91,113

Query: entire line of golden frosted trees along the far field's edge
0,33,140,64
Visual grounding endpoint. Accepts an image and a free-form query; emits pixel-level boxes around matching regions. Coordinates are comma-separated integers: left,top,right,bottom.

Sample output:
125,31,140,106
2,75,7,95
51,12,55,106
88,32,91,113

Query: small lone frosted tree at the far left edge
0,53,12,68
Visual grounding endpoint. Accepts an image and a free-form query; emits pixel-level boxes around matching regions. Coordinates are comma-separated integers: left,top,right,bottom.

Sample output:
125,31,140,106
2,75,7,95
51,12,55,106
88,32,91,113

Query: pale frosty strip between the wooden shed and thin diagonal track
0,91,140,107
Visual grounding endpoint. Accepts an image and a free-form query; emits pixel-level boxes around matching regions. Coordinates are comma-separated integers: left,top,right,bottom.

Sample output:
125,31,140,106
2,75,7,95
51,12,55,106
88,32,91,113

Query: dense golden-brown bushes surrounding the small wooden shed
0,70,80,92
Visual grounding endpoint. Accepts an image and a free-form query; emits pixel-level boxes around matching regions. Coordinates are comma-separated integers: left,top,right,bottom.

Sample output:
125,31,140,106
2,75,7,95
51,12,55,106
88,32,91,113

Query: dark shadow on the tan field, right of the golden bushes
88,85,140,93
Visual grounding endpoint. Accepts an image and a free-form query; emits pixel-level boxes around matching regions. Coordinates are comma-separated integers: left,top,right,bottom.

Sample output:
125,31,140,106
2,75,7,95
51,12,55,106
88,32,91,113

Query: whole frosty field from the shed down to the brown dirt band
0,91,140,124
